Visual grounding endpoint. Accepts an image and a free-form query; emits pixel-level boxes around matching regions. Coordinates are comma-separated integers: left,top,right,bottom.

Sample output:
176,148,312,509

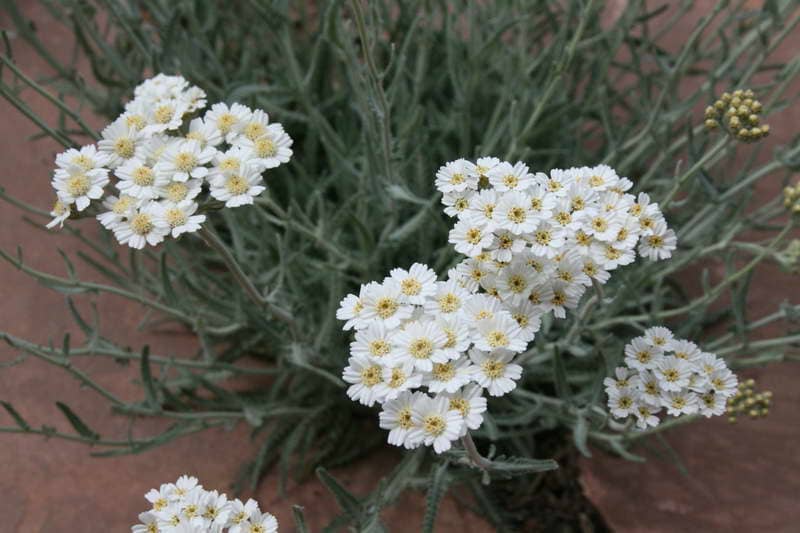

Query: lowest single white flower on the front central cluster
410,396,463,453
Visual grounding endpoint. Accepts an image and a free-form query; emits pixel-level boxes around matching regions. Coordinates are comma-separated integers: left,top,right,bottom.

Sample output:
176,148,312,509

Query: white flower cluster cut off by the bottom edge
131,476,278,533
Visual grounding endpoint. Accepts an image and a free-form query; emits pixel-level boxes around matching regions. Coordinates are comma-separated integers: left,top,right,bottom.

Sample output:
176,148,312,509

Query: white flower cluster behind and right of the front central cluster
436,157,676,318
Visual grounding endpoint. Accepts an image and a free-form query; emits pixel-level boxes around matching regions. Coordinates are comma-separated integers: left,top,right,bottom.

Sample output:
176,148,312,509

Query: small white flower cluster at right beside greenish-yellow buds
603,327,737,429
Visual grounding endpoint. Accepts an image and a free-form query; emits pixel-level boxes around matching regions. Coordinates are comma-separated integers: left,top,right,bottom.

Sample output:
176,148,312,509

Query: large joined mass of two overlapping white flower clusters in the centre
337,158,676,453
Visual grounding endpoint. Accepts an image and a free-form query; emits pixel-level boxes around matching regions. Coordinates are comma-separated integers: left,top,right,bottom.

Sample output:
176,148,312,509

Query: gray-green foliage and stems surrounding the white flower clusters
0,0,800,529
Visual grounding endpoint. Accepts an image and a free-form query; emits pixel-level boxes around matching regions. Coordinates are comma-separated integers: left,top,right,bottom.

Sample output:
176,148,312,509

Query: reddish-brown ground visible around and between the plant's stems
0,2,800,532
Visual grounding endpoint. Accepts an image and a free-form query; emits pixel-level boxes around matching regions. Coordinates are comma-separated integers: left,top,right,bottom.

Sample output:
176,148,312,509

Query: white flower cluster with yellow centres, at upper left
47,74,292,248
